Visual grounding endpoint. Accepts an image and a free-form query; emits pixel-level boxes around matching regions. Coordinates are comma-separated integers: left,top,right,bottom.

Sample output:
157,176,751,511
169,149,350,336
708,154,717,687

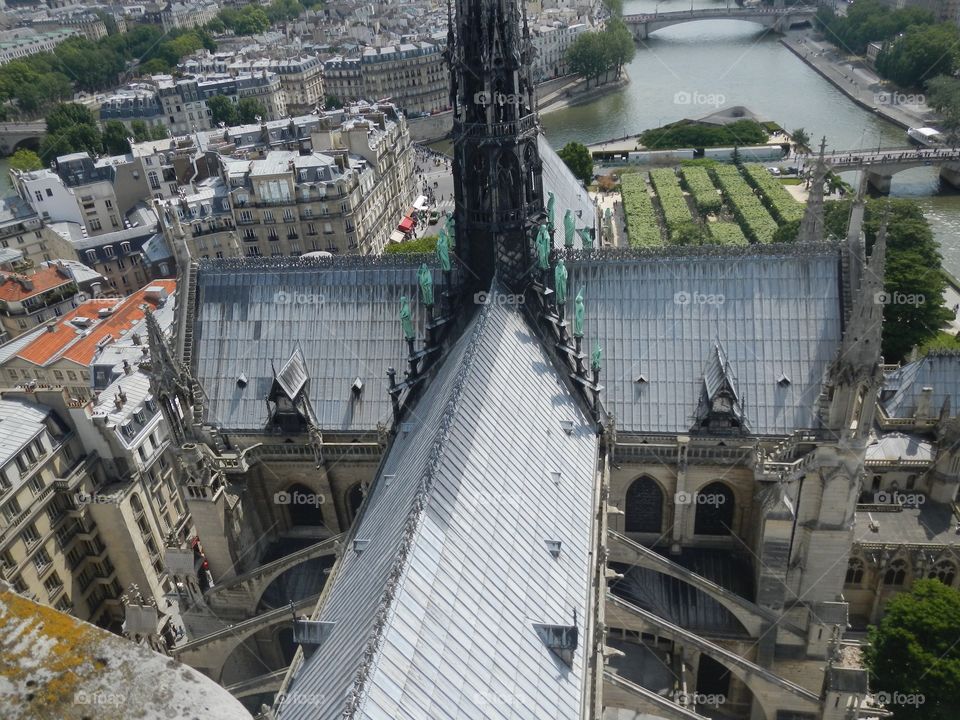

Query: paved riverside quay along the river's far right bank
780,37,936,128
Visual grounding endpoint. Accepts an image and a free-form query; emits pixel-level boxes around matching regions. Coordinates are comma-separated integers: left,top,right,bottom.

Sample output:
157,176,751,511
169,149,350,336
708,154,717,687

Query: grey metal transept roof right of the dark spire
567,244,842,435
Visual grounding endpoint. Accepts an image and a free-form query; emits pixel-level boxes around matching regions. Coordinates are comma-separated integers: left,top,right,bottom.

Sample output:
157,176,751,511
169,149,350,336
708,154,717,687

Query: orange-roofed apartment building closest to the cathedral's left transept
0,280,176,402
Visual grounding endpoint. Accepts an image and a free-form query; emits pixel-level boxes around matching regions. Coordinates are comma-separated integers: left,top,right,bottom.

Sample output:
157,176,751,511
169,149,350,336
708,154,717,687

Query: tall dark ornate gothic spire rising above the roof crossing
448,0,545,290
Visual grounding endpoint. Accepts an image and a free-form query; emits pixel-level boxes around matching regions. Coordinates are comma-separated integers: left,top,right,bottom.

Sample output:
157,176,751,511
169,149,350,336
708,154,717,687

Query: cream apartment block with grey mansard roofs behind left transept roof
157,105,413,259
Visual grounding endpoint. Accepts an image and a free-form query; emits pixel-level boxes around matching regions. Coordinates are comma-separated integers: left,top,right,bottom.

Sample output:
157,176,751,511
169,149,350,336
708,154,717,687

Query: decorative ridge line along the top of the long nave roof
343,292,502,720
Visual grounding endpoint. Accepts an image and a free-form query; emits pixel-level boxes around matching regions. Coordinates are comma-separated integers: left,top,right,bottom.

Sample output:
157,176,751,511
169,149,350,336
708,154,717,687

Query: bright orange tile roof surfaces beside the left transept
17,280,177,367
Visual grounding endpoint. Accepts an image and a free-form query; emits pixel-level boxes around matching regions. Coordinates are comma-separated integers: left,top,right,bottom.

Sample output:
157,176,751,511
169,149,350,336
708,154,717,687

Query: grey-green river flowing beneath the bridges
541,0,960,275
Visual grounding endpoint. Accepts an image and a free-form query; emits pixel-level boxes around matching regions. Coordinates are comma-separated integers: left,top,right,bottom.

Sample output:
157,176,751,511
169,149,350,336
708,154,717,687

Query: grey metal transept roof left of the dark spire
192,257,442,432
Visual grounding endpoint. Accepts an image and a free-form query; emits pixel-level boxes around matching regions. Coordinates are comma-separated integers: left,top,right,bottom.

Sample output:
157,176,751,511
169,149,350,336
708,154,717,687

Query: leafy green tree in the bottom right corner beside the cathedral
865,579,960,720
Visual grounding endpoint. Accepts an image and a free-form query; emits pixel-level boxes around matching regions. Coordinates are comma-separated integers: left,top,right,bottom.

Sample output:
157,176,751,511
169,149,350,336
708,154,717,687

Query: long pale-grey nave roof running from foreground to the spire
279,289,598,720
